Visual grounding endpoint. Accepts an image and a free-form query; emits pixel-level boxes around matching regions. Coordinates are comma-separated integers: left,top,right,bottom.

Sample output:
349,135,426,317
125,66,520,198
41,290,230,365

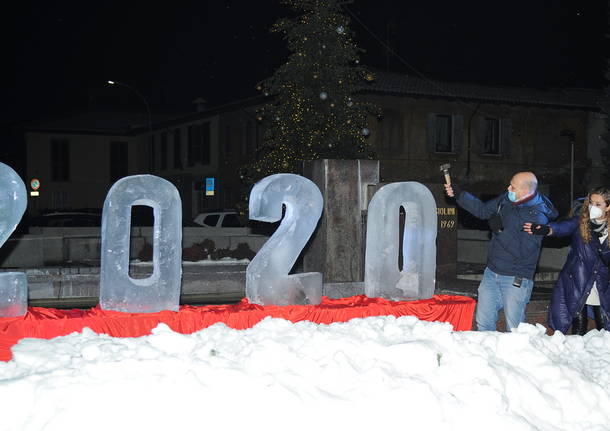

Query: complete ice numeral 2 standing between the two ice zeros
246,174,323,305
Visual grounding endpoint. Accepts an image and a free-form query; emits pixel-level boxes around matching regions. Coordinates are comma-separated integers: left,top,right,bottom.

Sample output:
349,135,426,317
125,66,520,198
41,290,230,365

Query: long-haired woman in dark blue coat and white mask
523,187,610,335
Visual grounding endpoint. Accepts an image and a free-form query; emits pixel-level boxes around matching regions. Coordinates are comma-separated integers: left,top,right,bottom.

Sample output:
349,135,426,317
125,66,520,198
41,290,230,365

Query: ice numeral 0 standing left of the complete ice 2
100,175,182,313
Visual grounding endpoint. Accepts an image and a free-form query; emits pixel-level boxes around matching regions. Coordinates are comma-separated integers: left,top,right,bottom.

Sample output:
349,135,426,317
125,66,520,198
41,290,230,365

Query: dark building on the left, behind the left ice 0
25,101,260,219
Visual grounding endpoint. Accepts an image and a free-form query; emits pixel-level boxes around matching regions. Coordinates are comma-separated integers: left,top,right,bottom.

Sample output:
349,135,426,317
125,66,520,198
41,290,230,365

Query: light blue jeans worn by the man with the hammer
476,268,534,332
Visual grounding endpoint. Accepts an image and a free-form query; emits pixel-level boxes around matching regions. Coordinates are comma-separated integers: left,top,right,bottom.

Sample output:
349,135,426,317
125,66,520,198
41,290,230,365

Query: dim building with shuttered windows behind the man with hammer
364,74,607,218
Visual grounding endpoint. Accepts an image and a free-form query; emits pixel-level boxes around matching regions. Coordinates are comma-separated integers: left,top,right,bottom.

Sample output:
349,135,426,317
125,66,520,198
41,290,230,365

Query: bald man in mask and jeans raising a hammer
441,165,557,331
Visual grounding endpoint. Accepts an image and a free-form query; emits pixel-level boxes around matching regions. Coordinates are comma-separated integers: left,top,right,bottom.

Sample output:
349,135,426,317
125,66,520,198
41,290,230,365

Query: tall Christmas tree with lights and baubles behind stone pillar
241,0,379,184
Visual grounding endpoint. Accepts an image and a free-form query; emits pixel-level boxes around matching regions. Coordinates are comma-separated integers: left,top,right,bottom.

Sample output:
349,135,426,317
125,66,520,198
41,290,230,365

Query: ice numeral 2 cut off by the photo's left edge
0,163,28,317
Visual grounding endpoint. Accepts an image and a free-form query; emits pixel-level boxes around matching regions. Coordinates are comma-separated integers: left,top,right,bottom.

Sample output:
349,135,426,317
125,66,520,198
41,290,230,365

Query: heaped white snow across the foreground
0,317,610,431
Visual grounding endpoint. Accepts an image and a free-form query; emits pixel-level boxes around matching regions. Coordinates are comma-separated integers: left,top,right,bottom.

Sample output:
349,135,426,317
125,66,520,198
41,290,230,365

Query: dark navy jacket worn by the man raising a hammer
456,191,557,280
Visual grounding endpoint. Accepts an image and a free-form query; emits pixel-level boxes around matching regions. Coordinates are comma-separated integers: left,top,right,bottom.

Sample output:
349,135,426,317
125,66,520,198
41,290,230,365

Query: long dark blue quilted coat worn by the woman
549,216,610,334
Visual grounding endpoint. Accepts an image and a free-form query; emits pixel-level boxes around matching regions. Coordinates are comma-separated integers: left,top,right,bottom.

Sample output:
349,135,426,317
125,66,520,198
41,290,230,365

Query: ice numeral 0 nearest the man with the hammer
364,182,437,300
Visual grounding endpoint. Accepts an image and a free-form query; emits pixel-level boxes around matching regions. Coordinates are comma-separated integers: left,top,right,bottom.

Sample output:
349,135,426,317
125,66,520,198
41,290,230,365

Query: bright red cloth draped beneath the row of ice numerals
0,295,476,361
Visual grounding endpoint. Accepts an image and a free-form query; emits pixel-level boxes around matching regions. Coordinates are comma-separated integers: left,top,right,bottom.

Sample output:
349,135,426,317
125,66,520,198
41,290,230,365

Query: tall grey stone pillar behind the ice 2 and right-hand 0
303,159,379,283
